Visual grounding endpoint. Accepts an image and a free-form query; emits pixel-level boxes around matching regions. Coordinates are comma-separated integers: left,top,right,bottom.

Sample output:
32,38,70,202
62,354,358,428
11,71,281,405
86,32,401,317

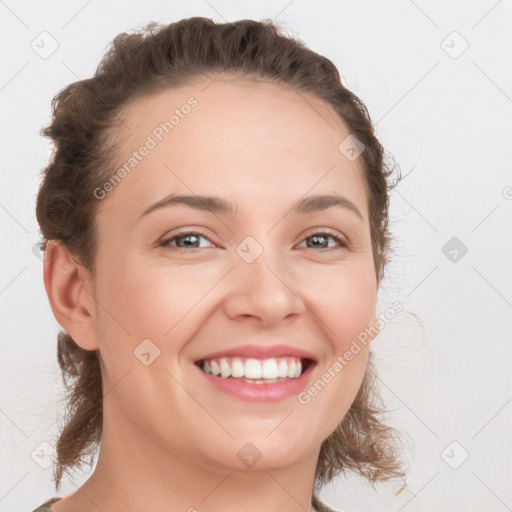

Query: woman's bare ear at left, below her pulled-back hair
43,240,99,350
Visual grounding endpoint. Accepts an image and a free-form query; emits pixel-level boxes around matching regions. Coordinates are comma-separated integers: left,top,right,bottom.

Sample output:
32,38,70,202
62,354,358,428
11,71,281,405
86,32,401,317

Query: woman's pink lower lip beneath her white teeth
194,364,315,402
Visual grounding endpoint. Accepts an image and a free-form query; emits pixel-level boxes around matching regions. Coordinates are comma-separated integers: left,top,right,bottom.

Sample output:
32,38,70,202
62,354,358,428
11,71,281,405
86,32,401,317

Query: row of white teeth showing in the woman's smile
202,357,302,383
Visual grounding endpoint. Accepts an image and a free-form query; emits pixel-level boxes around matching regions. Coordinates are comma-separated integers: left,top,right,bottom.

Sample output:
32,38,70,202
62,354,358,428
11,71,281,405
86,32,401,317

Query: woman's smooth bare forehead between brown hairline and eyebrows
97,75,366,220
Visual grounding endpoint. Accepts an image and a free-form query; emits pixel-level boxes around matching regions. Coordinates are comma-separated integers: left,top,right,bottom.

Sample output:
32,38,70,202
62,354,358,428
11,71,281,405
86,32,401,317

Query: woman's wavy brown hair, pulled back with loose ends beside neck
36,17,404,489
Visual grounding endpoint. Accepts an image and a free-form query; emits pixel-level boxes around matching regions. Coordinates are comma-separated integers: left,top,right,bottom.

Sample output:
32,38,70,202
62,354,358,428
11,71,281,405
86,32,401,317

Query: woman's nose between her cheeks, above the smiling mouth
224,245,306,327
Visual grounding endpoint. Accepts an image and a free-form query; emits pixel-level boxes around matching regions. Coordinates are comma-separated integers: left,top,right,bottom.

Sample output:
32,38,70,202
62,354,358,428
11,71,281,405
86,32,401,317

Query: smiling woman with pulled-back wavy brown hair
37,18,403,512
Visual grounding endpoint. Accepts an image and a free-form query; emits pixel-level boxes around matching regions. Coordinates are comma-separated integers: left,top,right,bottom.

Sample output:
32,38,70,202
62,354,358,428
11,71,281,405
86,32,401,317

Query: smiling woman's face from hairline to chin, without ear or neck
87,77,377,476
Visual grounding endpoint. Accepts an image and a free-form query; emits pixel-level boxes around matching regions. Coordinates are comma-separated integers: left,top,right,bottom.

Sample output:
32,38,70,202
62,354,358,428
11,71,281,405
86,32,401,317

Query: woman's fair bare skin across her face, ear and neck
44,75,377,512
